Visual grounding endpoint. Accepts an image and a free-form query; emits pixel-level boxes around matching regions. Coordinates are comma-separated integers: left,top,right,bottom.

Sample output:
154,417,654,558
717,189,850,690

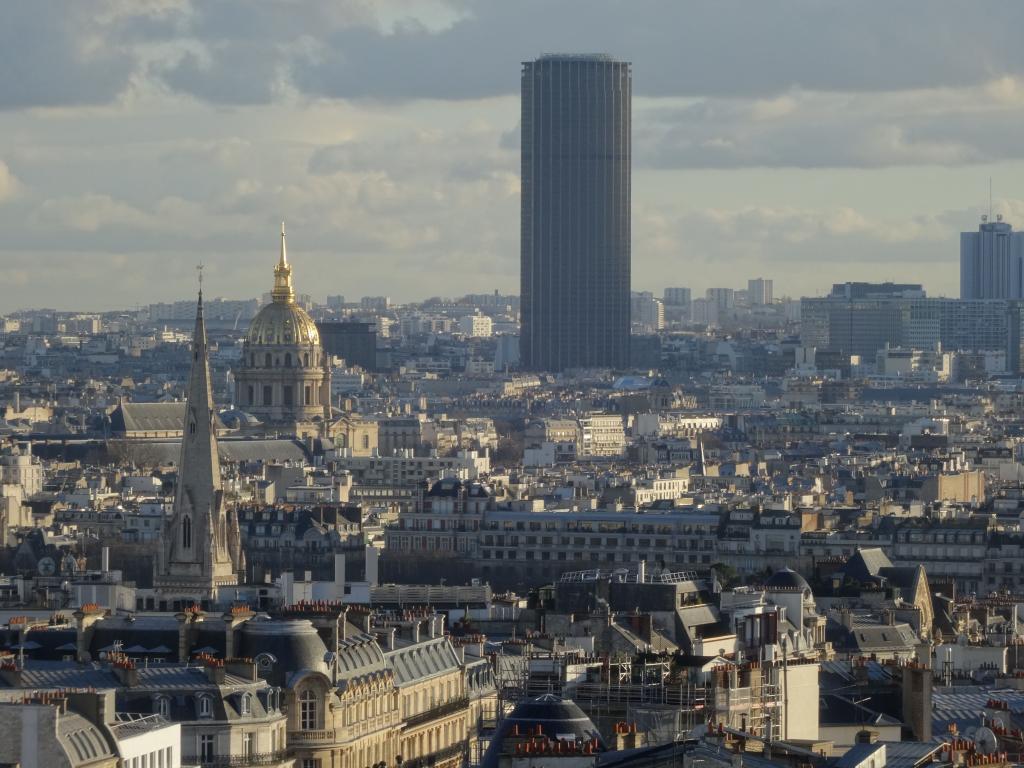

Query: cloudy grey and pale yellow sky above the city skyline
0,0,1024,314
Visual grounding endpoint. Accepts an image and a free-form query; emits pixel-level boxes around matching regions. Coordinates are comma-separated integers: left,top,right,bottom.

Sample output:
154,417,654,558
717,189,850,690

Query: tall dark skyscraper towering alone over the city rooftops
520,55,633,371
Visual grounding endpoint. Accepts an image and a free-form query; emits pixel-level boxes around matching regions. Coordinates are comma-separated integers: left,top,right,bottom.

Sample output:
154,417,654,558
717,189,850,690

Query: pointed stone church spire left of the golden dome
154,288,241,602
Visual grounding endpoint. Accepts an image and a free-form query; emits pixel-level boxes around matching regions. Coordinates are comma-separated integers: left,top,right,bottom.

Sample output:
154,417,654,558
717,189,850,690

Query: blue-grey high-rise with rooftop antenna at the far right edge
961,216,1024,299
